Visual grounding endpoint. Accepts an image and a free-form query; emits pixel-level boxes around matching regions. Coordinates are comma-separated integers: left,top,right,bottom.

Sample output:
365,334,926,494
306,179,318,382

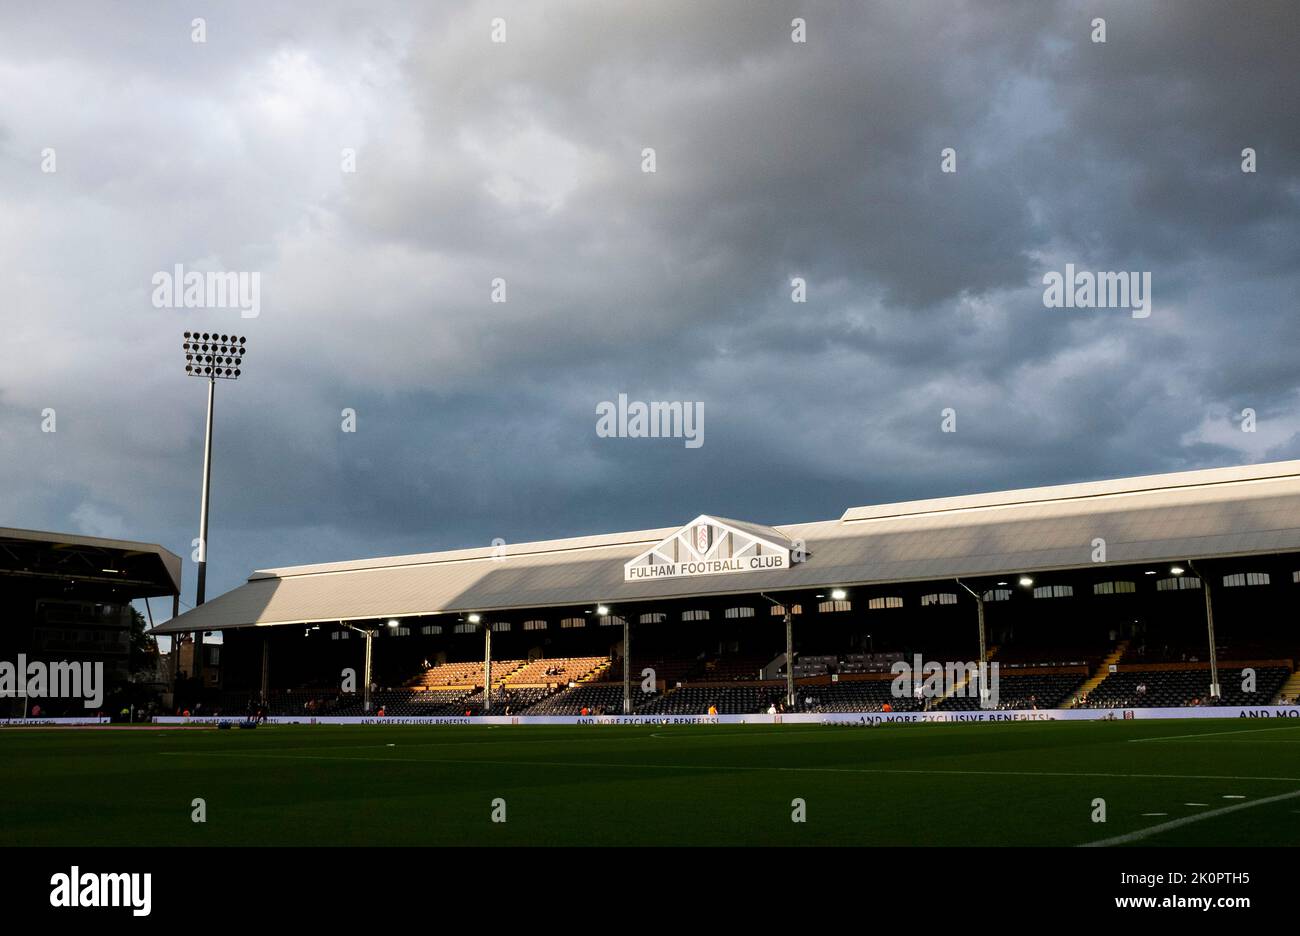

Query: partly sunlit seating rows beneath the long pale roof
200,621,1300,716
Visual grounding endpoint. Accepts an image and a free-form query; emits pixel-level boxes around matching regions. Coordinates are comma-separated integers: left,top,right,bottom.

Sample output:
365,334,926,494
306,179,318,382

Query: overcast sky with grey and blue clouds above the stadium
0,0,1300,603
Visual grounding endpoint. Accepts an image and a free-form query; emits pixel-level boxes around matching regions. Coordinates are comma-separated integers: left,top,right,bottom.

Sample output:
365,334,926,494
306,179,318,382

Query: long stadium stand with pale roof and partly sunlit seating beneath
152,462,1300,714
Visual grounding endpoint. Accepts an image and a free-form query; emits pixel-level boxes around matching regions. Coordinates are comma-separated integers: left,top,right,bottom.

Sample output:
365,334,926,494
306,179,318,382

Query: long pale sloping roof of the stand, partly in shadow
156,462,1300,633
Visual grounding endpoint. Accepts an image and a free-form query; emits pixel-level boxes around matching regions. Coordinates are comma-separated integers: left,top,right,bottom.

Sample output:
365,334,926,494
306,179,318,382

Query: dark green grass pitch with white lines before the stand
0,719,1300,846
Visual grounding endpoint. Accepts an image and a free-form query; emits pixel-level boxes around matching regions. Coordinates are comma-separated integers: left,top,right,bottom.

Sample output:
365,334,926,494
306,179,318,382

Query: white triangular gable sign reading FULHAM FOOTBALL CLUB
623,515,790,581
